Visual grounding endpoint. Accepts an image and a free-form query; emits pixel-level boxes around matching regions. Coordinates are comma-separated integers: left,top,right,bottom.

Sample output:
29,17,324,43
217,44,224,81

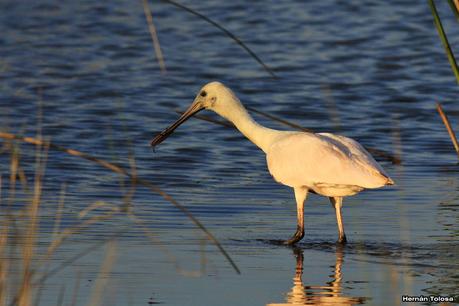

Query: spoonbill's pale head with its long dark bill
150,82,242,147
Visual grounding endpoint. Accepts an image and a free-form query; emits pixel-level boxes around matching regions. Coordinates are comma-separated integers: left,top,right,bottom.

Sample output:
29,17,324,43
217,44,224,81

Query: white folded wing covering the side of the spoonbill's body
266,133,388,188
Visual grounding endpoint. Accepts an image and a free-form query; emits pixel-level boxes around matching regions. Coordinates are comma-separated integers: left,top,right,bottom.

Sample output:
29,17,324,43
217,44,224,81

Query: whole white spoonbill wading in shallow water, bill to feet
151,82,394,245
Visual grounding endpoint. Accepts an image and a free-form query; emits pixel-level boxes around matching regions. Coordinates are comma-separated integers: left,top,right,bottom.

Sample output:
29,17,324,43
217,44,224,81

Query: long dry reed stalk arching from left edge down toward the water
0,132,241,274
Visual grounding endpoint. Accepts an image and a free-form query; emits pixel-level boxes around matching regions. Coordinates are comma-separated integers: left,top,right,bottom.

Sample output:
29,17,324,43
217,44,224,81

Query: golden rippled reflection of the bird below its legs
267,245,365,306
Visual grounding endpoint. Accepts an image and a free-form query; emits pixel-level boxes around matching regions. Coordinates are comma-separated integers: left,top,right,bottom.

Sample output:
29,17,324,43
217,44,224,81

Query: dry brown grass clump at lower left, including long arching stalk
0,132,243,306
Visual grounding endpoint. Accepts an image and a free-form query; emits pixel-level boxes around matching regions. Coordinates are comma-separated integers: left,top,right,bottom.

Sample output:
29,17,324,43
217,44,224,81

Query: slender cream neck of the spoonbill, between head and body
220,101,283,153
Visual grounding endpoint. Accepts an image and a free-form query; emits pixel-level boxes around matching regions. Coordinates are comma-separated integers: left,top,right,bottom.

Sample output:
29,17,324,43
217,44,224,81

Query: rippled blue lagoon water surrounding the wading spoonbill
0,1,459,305
